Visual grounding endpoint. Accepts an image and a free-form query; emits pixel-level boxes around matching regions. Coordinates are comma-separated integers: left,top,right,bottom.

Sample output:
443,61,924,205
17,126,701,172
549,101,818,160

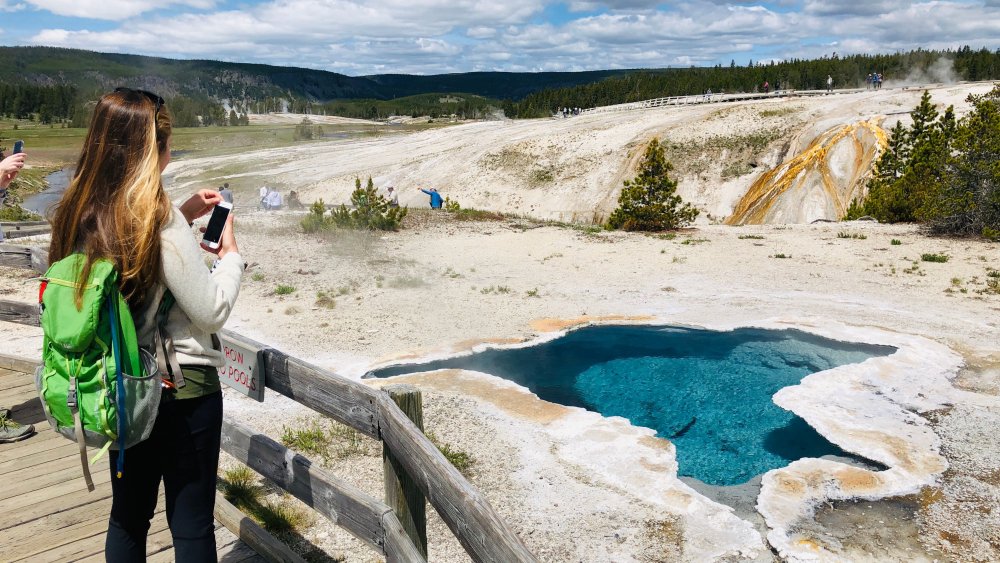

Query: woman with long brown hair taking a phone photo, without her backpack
49,88,243,562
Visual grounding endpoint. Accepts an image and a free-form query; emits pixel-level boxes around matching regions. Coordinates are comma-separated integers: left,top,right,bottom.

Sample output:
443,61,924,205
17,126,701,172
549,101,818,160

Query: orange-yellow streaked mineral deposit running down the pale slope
726,116,888,225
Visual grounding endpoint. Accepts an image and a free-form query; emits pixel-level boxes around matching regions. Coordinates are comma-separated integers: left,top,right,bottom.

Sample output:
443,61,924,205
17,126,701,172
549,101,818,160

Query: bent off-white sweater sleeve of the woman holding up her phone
161,208,243,333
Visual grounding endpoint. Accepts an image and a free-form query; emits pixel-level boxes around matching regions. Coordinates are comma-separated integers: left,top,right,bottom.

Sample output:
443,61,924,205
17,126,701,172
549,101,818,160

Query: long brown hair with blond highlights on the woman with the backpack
49,89,171,307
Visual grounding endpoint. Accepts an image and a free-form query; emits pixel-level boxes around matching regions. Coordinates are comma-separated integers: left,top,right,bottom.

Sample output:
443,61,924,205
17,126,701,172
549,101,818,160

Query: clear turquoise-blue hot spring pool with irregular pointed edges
369,326,895,485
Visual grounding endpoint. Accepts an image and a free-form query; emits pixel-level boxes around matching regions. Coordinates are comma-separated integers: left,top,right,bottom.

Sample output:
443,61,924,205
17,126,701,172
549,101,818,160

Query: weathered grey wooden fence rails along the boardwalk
0,245,536,563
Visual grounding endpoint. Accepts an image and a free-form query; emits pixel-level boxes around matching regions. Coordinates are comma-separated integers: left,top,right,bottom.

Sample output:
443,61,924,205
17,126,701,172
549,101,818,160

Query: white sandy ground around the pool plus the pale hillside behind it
0,85,1000,561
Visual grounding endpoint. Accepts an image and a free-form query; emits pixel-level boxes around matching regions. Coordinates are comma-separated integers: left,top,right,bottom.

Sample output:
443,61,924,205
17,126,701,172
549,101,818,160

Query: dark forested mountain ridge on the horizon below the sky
0,47,630,102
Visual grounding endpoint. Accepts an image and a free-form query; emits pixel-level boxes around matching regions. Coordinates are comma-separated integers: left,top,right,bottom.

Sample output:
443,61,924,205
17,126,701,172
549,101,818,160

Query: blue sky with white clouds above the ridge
0,0,1000,75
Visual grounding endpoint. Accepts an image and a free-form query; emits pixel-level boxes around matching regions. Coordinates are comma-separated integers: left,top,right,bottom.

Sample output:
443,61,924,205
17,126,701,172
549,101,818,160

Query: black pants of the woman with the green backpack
105,392,222,563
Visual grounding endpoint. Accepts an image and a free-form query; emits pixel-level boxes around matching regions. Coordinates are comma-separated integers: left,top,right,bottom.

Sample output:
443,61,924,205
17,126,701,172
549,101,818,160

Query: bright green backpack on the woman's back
35,253,174,491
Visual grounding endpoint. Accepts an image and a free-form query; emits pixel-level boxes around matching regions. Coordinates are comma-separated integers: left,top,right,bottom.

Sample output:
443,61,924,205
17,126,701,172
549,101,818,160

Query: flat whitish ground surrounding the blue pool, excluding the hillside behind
4,212,1000,561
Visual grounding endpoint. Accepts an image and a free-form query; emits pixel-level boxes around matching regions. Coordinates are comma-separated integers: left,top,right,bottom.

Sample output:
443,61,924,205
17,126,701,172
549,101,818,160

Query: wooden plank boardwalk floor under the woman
0,357,264,563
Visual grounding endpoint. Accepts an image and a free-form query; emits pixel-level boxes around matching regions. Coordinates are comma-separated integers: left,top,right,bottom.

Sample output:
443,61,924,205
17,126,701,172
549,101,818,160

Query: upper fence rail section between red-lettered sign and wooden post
224,331,378,439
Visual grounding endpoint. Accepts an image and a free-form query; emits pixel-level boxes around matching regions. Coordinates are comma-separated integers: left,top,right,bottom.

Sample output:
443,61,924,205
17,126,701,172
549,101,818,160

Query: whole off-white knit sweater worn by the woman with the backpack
135,207,243,367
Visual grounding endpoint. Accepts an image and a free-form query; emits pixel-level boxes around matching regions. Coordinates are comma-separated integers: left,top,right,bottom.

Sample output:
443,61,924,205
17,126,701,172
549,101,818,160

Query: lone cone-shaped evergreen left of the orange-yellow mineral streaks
607,138,698,231
